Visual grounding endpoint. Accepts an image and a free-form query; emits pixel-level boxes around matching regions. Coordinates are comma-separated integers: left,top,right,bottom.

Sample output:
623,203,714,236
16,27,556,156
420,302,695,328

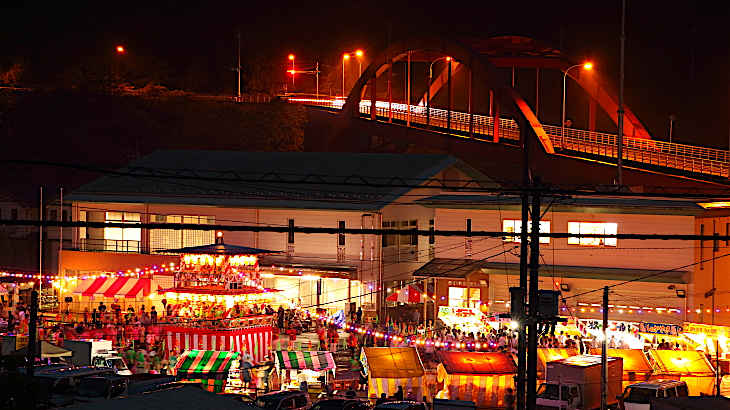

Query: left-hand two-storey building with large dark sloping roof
61,151,486,316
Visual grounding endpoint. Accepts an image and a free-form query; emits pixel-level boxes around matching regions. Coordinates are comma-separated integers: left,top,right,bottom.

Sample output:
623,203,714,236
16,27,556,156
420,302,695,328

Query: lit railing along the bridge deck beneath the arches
287,96,730,177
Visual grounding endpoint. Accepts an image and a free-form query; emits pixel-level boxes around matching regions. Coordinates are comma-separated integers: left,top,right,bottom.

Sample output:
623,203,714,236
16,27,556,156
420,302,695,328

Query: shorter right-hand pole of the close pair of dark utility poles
526,187,540,409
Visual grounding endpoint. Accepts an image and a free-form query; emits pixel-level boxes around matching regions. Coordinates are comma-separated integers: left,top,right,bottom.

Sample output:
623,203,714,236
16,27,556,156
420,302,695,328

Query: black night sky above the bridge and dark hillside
0,0,730,148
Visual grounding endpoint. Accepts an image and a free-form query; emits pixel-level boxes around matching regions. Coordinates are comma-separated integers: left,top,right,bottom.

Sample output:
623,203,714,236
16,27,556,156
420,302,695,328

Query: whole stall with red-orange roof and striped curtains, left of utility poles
436,352,517,408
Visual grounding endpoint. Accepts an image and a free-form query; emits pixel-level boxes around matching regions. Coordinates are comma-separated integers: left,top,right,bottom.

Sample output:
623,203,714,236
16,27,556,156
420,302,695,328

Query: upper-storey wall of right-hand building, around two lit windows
436,209,694,269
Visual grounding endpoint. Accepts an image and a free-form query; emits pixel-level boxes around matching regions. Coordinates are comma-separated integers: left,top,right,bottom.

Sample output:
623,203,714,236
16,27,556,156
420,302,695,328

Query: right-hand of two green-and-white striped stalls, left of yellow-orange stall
274,350,336,391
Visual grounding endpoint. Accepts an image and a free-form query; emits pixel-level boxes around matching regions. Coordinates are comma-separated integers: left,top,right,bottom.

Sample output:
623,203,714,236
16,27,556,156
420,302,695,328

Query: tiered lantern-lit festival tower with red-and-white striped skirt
160,233,278,364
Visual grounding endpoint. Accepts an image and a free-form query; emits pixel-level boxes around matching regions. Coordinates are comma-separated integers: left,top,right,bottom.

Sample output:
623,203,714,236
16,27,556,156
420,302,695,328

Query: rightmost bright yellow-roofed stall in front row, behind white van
649,350,715,396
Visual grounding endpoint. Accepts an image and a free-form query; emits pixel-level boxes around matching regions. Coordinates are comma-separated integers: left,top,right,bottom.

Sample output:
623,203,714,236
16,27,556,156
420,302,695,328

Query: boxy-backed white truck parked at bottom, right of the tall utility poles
537,355,623,410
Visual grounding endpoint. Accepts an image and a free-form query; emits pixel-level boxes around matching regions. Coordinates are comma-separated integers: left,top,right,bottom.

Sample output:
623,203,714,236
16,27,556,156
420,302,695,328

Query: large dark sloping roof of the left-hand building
69,150,486,211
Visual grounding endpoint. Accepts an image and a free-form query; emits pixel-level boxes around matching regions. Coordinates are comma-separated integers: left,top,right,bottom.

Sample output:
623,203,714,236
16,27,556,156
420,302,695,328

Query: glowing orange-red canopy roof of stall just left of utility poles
437,352,517,375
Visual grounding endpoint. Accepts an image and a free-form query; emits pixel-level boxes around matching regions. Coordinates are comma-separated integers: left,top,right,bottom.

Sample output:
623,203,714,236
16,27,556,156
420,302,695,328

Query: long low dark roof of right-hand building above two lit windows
416,194,704,215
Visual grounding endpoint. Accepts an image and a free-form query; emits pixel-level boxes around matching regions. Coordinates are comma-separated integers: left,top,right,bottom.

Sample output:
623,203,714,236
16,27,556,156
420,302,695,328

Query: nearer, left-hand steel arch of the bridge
340,37,555,153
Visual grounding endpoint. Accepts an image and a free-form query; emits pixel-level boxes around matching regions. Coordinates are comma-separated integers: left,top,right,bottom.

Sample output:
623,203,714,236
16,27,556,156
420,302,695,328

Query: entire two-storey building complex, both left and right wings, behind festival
61,151,730,324
